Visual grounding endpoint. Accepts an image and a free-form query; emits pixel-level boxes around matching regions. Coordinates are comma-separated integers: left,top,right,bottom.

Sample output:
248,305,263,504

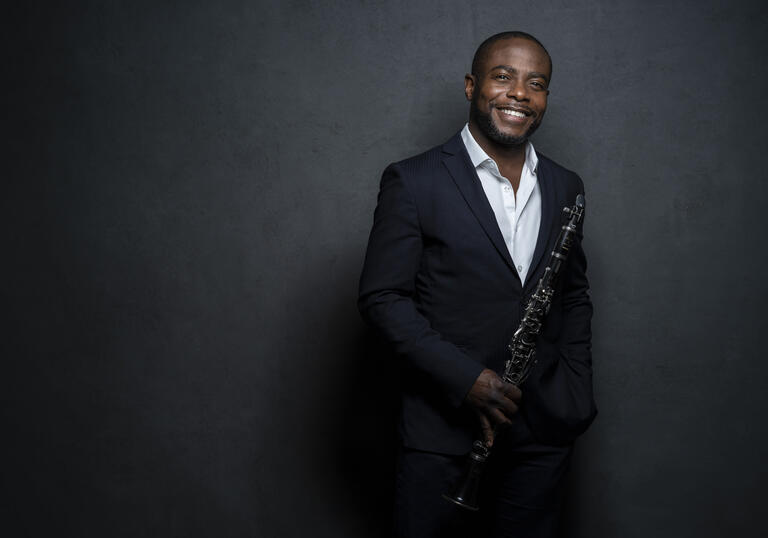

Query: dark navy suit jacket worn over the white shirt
358,134,596,454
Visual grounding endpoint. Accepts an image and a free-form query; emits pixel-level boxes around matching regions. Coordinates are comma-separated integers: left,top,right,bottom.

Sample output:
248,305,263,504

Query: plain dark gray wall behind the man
6,0,768,538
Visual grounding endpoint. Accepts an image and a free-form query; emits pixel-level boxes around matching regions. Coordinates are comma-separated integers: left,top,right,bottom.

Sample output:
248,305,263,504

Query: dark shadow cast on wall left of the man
282,249,398,537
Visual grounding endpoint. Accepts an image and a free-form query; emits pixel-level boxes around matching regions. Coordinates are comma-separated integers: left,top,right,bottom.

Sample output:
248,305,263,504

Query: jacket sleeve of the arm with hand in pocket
524,176,597,444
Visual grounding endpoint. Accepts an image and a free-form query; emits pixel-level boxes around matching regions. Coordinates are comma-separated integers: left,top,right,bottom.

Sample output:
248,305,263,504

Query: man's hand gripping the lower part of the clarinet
464,368,523,447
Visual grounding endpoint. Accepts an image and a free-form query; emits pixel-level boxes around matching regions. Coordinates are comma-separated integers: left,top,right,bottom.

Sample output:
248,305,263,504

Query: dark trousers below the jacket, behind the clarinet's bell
395,428,572,538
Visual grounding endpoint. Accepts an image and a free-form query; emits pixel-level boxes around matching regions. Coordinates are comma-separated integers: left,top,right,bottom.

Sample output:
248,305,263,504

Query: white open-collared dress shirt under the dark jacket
461,124,541,283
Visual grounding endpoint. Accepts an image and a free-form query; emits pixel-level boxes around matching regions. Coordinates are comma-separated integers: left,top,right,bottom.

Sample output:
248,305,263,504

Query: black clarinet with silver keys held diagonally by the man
443,194,584,510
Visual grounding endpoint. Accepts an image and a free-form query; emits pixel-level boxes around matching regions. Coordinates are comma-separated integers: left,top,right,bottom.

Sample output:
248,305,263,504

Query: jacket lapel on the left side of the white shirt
443,133,520,285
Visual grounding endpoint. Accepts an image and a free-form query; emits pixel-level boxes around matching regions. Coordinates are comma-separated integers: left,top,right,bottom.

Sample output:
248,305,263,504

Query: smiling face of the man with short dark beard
464,38,552,146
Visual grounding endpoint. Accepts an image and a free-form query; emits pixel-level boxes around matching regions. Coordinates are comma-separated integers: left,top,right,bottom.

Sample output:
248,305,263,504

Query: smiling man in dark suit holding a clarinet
359,32,596,538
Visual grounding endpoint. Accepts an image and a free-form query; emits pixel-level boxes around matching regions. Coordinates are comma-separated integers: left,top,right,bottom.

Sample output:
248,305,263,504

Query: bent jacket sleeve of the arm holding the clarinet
358,165,483,407
